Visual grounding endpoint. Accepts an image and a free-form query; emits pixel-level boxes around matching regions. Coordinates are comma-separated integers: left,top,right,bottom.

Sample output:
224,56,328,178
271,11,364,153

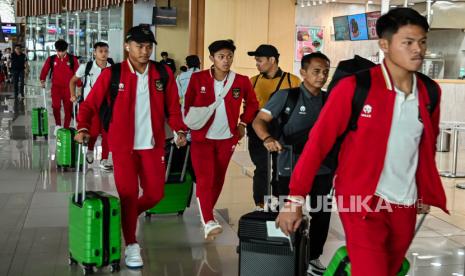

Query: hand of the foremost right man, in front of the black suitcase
276,201,303,236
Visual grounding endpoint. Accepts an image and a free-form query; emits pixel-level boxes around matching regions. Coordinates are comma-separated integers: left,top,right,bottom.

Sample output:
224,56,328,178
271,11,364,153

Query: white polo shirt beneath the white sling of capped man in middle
206,79,233,140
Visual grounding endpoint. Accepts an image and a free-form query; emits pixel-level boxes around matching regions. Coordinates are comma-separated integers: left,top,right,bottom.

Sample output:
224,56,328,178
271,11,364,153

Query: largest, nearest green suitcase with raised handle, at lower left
69,142,121,275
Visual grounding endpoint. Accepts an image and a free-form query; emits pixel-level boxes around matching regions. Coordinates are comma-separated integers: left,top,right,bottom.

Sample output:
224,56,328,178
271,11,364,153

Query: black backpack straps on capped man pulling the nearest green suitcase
99,61,169,132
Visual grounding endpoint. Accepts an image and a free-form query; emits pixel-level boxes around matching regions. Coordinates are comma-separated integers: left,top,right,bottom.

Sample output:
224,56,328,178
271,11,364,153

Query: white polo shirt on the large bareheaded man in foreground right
375,75,423,205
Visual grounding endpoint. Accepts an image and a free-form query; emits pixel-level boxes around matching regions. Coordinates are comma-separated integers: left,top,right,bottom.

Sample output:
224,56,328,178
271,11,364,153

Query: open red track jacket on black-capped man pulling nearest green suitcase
78,60,187,152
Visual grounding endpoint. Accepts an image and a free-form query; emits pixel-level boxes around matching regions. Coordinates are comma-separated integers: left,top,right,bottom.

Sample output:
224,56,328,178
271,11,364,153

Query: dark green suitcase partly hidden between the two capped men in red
145,144,193,217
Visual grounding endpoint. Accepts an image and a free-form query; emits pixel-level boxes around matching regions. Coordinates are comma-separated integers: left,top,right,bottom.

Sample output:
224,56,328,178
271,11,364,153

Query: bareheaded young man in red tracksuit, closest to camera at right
277,8,447,276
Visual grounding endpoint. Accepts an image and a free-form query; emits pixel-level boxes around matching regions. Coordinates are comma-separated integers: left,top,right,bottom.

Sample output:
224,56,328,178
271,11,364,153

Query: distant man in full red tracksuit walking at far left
40,39,79,135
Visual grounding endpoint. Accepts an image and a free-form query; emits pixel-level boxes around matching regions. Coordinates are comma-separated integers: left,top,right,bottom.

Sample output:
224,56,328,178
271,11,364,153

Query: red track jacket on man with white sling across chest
184,70,258,142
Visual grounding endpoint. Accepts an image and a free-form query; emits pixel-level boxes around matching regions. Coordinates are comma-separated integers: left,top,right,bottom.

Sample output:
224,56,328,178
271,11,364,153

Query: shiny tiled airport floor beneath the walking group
0,81,465,276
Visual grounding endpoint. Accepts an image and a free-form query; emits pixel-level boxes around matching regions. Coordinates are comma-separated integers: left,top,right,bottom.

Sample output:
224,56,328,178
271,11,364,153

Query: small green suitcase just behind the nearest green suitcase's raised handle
55,128,84,170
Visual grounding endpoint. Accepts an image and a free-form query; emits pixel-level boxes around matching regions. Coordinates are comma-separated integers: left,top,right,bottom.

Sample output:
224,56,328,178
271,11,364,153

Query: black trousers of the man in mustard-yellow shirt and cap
247,126,278,205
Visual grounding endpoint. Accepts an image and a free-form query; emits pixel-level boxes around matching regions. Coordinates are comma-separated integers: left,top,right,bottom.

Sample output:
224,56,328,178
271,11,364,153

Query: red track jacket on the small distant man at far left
40,54,79,89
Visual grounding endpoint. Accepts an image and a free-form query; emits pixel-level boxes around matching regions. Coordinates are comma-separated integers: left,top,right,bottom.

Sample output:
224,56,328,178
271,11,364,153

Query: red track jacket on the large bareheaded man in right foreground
290,64,448,212
